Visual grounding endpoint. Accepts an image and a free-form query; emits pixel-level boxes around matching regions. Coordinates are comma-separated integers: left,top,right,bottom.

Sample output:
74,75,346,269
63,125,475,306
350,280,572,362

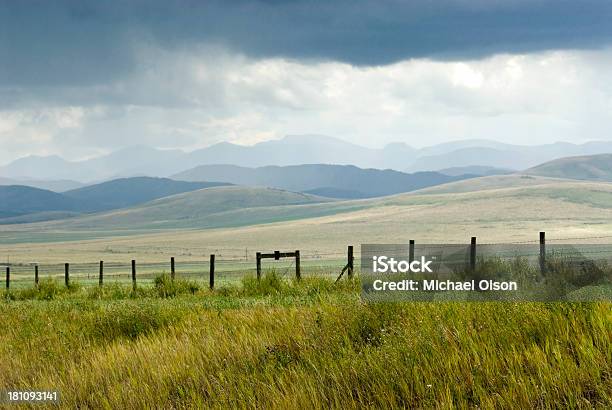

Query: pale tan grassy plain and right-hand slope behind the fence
0,176,612,263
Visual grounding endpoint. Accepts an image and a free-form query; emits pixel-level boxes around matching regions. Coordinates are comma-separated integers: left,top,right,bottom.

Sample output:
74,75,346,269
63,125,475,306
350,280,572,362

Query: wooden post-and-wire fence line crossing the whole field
5,232,612,289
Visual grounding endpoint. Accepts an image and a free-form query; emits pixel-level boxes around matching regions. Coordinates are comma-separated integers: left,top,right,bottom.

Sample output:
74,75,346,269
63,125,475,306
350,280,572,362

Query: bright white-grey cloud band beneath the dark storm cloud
0,49,612,163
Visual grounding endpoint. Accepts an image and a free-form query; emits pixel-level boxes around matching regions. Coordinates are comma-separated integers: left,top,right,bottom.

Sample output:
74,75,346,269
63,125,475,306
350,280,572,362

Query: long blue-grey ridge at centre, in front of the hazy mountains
173,164,473,199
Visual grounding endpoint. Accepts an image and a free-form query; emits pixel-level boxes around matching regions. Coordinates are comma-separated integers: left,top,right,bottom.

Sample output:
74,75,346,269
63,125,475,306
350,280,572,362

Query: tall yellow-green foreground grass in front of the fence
0,275,612,408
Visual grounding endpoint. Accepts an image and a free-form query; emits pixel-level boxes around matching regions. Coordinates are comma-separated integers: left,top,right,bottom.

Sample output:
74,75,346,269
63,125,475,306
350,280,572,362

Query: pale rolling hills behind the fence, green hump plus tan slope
5,175,612,250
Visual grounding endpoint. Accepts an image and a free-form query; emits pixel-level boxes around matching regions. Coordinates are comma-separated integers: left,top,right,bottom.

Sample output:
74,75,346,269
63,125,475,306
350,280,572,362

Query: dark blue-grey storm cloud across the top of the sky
0,0,612,87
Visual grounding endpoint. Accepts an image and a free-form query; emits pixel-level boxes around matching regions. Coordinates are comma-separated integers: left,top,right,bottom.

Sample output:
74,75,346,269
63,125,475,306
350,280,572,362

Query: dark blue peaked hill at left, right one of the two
64,177,228,211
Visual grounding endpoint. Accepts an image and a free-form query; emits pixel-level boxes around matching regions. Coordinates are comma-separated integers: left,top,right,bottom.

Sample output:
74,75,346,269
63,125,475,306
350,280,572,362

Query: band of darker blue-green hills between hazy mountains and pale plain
0,154,612,230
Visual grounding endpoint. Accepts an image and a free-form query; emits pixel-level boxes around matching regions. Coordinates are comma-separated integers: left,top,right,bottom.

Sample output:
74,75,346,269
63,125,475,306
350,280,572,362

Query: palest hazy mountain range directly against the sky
0,135,612,182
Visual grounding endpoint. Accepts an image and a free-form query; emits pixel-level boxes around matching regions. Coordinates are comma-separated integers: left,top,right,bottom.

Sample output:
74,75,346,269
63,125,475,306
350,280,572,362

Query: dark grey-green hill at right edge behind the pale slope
525,154,612,181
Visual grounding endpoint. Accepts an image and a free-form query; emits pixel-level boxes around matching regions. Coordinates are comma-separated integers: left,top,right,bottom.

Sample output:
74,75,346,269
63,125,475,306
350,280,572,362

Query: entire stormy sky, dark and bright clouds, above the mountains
0,0,612,163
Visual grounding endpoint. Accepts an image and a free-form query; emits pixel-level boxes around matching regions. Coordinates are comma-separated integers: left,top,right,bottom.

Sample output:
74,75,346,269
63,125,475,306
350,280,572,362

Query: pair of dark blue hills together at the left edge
0,177,228,223
